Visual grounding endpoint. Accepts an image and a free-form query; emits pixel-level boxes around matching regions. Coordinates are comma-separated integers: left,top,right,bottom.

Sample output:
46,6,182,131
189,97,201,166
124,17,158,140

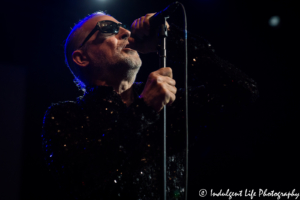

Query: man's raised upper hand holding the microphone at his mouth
128,13,169,53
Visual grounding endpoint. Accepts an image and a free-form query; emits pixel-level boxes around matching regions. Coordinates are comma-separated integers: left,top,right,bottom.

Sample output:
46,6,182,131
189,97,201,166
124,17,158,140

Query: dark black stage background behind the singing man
0,0,300,200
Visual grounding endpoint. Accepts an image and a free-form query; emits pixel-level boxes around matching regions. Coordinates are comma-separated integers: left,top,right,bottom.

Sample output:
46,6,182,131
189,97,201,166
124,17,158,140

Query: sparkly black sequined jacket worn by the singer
42,27,258,200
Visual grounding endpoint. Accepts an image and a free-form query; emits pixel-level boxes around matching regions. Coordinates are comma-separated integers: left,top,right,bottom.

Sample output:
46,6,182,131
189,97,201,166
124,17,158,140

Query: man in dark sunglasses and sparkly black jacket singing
42,12,257,200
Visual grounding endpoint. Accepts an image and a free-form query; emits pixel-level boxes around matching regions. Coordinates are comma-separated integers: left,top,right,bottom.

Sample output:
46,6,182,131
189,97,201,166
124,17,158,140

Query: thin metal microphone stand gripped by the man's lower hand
158,17,169,200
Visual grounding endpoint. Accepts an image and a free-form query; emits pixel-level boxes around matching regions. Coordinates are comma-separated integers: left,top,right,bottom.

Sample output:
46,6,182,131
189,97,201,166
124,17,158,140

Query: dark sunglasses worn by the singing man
79,20,126,48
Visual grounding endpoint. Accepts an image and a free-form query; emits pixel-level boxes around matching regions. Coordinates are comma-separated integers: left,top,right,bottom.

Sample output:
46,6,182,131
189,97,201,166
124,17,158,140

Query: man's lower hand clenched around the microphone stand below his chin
140,67,177,112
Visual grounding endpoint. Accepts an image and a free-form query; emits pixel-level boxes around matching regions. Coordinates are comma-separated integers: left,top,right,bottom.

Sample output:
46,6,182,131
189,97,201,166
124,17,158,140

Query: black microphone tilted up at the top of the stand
149,1,179,29
